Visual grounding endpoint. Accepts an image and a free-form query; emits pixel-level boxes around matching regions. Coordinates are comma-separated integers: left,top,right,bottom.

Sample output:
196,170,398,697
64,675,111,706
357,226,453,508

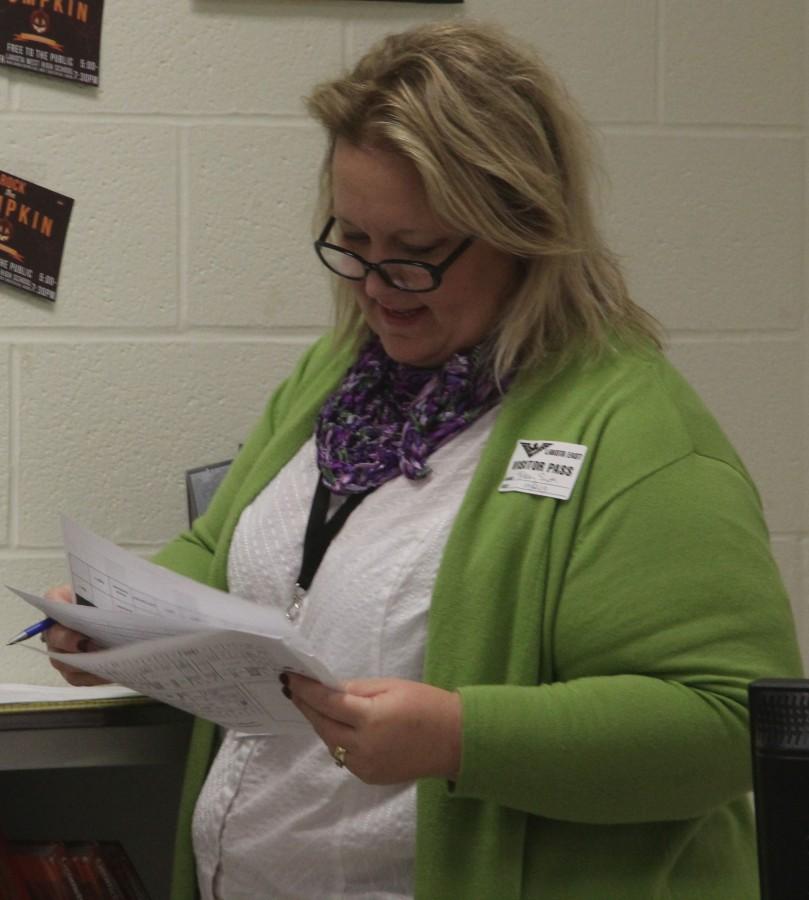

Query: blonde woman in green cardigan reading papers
49,24,800,900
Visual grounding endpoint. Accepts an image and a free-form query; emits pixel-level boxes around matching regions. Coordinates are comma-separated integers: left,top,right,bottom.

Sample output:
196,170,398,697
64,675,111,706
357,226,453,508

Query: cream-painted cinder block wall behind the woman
0,0,809,683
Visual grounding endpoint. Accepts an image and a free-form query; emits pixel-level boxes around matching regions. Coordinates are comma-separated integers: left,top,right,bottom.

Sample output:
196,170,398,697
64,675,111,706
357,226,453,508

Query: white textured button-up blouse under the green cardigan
193,408,496,900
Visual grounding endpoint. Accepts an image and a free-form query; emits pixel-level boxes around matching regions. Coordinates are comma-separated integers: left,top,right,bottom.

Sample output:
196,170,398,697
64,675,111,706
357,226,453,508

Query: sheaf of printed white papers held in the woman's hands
9,517,339,734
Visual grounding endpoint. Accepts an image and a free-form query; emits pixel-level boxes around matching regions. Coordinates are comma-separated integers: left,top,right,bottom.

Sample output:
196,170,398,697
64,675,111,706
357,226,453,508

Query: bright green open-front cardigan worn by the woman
157,336,801,900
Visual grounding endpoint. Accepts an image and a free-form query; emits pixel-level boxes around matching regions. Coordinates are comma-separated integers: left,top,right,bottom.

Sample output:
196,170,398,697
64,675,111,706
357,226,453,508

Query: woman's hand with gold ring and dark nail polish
288,673,461,784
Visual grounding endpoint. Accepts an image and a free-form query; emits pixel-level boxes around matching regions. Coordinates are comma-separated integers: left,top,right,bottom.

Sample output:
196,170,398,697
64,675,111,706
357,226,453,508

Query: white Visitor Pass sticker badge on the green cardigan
499,440,587,500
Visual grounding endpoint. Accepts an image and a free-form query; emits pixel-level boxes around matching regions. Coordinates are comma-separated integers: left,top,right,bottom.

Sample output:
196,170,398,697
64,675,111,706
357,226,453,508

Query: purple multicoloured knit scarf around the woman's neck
315,338,500,494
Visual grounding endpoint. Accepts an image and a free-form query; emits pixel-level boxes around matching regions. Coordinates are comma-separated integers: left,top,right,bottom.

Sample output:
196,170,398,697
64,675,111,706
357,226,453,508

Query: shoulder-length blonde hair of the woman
307,22,659,378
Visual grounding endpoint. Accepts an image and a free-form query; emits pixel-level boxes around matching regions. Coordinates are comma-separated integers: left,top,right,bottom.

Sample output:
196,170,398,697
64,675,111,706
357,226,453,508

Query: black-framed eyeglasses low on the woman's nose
315,216,474,293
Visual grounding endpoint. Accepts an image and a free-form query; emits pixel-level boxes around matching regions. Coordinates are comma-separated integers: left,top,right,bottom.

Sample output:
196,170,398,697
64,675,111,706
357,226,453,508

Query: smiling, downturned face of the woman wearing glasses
328,139,516,366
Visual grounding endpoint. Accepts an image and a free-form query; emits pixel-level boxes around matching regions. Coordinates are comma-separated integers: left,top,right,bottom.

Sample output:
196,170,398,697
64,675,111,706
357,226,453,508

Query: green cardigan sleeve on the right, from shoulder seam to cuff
454,453,801,824
